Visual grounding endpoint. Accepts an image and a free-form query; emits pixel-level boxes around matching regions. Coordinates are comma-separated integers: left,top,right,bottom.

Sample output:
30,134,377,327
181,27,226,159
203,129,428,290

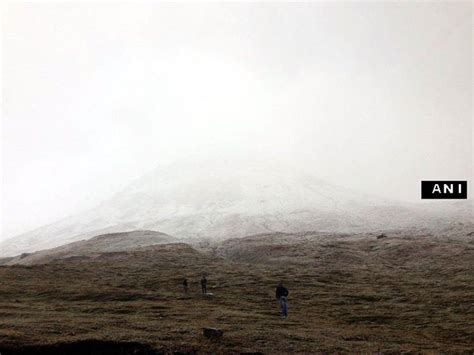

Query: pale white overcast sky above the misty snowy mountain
1,2,473,238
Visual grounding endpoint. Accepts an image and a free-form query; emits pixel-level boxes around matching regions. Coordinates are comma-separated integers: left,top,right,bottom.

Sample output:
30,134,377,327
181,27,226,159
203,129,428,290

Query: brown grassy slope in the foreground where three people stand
0,224,474,355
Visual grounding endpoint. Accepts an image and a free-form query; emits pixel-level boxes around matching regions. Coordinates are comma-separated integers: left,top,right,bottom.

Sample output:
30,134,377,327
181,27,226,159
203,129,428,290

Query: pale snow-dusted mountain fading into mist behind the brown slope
0,160,466,256
